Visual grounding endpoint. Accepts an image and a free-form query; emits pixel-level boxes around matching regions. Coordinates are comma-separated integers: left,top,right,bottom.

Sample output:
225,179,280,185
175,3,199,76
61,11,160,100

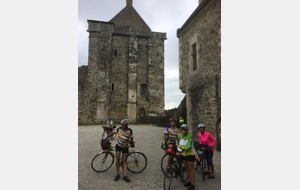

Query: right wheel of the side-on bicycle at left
127,152,147,173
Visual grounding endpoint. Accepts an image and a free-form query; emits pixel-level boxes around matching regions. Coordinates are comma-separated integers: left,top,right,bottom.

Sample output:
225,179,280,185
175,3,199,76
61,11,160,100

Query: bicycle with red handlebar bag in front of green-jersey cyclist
161,144,187,190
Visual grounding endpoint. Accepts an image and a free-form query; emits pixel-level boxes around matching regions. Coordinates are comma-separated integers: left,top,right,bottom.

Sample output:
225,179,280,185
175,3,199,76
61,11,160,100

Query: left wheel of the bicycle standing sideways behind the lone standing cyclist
91,152,114,172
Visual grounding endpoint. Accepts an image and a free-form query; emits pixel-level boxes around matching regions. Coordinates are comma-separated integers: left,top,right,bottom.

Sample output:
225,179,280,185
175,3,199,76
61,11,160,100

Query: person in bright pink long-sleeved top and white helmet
198,124,216,179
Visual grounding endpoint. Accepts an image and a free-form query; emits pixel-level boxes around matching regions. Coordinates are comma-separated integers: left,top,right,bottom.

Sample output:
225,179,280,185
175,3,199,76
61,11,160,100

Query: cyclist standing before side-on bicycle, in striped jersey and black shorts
106,119,133,182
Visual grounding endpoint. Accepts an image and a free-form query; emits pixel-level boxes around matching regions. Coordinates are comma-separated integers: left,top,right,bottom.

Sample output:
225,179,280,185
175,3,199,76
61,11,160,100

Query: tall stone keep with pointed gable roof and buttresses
78,0,166,124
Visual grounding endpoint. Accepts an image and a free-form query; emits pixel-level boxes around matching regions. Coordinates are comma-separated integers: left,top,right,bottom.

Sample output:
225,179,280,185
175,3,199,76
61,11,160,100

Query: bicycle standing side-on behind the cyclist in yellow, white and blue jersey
91,141,147,173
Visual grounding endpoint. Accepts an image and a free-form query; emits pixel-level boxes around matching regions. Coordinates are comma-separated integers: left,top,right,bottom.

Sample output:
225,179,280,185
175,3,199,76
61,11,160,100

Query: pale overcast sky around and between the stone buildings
78,0,198,109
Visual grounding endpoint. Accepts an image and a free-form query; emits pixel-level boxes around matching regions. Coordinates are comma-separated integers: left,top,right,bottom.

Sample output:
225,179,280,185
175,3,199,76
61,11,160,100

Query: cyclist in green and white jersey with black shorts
178,124,195,190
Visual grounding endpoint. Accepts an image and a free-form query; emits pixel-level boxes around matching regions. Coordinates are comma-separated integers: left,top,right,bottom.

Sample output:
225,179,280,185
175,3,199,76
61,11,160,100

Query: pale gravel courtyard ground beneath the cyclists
78,125,221,190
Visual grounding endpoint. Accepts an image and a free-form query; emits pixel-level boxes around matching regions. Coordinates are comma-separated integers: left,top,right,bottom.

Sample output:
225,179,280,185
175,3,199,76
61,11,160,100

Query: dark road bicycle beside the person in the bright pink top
194,143,208,181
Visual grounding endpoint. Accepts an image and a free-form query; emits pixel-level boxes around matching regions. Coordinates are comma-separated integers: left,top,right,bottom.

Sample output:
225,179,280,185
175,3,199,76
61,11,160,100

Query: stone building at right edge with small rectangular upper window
177,0,221,150
